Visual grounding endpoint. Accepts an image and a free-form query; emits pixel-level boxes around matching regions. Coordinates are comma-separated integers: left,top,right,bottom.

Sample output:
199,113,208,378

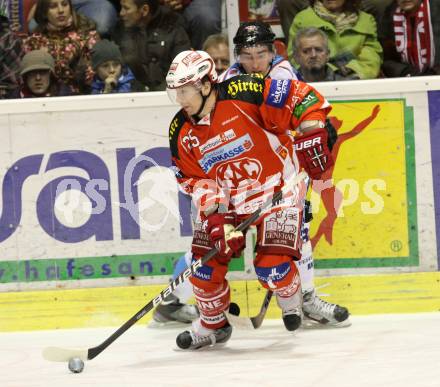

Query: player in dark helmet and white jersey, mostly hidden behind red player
153,21,349,325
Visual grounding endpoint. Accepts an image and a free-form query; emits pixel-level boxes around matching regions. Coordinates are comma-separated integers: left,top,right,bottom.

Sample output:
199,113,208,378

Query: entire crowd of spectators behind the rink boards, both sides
0,0,440,98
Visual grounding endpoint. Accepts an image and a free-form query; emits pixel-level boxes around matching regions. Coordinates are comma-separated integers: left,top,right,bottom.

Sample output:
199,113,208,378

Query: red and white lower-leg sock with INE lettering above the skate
193,280,231,329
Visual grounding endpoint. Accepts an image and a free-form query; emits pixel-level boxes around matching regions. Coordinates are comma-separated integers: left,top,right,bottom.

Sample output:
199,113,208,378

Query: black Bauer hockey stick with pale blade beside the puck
43,171,307,362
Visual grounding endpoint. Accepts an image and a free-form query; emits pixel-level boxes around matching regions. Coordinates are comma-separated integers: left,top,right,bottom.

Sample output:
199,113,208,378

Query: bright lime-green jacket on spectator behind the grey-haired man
287,7,382,79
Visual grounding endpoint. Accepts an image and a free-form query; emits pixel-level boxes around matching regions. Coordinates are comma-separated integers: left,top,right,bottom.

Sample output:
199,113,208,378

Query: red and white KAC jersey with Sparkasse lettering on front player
169,75,331,214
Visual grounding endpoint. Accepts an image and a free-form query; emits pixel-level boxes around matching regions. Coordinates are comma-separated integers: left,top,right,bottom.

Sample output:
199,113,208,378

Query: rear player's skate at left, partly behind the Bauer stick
153,294,199,324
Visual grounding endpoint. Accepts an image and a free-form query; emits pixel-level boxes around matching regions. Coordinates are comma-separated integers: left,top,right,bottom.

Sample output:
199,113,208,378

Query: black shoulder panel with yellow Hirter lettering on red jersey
218,74,265,105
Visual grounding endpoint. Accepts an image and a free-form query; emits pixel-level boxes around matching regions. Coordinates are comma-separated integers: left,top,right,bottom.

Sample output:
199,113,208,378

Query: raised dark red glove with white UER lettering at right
295,128,334,180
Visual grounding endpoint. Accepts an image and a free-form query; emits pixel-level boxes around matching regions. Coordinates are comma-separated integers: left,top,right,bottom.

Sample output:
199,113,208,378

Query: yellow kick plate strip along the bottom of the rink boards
0,272,440,332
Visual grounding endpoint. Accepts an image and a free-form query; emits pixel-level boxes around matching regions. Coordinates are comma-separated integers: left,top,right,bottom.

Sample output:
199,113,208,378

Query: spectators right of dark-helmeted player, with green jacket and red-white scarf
284,0,440,80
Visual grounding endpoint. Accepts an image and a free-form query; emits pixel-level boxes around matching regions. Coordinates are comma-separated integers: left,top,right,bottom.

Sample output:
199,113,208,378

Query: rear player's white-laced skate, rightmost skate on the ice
302,290,350,326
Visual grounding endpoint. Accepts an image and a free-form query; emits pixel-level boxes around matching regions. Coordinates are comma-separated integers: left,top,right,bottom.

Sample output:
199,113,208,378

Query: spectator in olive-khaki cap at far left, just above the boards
8,50,74,98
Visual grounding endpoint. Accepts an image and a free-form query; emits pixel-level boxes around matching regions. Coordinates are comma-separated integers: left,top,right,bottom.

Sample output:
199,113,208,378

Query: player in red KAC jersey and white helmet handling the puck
167,51,333,349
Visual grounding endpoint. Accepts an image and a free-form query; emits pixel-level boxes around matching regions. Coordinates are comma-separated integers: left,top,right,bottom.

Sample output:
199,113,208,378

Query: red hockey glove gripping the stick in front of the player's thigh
206,212,245,258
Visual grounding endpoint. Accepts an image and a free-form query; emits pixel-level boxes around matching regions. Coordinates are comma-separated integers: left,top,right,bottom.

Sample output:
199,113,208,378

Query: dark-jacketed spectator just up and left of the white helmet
111,0,191,91
